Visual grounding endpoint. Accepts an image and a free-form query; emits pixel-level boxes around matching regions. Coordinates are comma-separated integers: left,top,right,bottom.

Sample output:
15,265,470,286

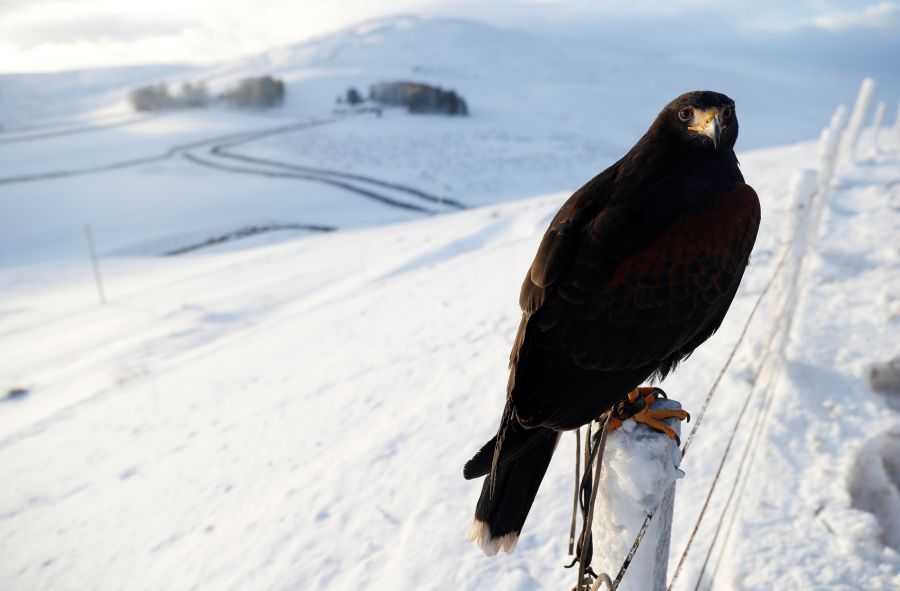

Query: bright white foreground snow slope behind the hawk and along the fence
0,126,900,589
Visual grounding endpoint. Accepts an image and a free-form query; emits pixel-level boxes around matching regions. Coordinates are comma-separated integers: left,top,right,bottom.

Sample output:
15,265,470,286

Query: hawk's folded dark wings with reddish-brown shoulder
508,184,760,427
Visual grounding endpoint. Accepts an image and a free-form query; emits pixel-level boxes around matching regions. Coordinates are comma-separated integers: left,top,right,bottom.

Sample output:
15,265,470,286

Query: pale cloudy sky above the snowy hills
0,0,900,72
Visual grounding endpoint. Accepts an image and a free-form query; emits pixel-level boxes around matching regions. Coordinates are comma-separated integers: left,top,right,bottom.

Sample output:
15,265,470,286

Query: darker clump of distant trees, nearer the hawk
338,81,469,115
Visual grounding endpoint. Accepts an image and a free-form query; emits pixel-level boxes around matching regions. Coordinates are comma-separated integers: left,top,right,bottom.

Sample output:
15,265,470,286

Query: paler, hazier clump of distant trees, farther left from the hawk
128,76,284,111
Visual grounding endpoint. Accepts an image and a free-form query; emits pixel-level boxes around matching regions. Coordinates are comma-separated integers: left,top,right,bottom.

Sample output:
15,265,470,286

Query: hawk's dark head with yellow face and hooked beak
658,90,738,150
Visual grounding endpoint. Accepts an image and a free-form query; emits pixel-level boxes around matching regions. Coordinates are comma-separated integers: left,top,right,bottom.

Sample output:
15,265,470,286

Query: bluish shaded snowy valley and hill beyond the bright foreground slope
0,17,896,264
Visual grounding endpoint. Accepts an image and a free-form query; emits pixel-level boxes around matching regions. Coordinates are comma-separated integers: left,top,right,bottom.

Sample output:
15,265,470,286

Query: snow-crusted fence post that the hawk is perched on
591,399,684,591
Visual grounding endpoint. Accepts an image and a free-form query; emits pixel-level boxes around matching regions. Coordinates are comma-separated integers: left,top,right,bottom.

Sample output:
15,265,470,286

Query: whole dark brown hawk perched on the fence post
464,91,760,554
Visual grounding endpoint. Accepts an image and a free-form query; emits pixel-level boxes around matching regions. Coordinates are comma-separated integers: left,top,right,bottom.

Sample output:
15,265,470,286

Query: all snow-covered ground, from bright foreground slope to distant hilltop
0,13,900,591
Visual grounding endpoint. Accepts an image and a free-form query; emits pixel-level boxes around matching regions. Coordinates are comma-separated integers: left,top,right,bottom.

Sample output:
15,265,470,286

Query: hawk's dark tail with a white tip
464,422,559,556
